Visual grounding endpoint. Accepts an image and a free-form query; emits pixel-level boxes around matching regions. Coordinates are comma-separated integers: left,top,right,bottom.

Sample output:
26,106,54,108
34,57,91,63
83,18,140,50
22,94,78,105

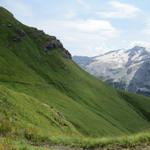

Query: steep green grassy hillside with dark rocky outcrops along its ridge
0,7,150,147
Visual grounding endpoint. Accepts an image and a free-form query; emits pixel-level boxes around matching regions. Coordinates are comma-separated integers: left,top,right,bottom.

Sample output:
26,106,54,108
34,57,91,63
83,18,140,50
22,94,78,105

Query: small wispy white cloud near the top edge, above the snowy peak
98,1,140,18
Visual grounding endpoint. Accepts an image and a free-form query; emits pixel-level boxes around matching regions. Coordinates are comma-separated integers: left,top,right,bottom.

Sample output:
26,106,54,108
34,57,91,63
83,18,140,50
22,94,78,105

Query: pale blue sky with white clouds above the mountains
0,0,150,56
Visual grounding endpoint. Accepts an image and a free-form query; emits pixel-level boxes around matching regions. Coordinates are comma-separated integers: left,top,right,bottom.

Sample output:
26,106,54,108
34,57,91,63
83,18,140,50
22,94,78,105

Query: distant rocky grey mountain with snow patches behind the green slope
73,46,150,95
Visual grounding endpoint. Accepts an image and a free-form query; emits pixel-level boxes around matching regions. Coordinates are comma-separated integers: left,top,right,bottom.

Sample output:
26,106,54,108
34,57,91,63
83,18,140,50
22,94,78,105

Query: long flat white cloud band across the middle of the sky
33,20,119,39
